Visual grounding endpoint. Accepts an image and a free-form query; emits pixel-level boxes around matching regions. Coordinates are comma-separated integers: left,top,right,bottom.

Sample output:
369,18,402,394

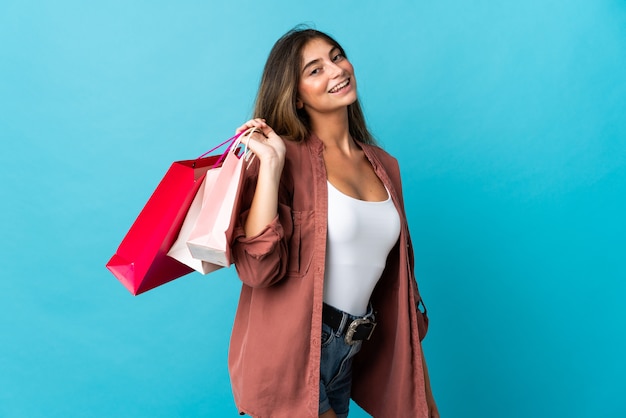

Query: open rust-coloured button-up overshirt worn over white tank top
228,135,428,418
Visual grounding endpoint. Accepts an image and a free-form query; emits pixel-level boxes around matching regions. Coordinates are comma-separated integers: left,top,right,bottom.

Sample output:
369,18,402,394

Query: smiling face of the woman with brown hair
296,39,357,117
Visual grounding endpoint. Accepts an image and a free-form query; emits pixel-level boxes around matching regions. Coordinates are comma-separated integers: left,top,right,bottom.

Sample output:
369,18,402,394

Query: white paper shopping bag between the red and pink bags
167,167,222,274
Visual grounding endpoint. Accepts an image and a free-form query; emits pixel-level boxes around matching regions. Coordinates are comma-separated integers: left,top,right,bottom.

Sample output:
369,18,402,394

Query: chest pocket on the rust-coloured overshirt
287,210,315,277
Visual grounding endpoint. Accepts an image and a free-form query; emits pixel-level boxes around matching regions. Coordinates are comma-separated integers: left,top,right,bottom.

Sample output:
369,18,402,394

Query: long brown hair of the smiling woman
254,27,376,144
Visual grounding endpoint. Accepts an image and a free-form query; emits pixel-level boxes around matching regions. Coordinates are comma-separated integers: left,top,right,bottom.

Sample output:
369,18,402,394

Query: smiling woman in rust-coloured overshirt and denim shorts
229,29,439,418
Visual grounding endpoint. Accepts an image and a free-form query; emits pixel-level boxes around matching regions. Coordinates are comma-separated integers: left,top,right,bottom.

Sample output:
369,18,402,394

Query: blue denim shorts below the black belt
319,308,372,418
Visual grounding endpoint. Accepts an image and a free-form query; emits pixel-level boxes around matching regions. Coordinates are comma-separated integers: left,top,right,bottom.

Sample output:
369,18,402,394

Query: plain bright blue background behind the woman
0,0,626,418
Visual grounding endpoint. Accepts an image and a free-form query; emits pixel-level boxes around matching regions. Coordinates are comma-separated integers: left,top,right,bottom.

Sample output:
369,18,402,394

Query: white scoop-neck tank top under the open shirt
324,182,400,316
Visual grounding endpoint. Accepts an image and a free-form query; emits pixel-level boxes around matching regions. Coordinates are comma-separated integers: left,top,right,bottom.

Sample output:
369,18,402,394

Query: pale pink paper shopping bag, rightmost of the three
187,129,254,267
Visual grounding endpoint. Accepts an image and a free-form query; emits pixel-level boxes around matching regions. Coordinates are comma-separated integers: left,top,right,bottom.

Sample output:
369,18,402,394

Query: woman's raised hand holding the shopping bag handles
236,118,285,173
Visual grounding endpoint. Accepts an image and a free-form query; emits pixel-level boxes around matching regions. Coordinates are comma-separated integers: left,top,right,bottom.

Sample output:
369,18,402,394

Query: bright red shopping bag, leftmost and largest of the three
106,136,237,295
